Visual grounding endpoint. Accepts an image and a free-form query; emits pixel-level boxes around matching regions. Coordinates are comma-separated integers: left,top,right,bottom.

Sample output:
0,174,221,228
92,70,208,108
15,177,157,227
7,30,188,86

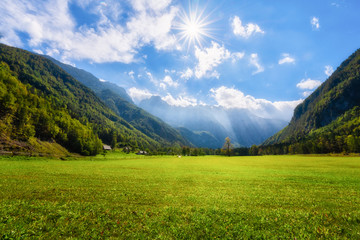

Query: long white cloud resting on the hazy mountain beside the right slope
210,86,302,121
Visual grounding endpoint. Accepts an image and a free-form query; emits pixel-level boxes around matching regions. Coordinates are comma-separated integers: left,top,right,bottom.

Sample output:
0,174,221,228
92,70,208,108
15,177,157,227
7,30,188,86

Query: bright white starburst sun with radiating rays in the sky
174,4,214,49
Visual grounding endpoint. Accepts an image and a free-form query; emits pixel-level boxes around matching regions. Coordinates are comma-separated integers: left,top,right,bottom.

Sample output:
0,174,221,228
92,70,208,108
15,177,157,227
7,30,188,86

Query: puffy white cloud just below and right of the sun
195,41,231,78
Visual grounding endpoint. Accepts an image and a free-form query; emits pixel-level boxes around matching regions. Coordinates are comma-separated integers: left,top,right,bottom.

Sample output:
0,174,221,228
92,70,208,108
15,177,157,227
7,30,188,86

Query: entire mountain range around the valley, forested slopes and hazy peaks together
0,44,360,155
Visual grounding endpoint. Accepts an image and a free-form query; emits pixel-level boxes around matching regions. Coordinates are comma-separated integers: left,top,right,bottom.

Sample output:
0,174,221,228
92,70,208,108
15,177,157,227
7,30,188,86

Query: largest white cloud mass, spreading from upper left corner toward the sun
0,0,178,63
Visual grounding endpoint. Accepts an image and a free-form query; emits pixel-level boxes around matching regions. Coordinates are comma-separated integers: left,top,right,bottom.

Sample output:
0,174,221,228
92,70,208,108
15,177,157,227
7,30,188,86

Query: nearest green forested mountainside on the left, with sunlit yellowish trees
0,44,160,155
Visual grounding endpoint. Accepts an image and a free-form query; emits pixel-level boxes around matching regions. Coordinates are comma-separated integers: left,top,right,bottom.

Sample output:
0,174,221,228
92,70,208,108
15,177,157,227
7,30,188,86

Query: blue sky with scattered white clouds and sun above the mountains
0,0,360,121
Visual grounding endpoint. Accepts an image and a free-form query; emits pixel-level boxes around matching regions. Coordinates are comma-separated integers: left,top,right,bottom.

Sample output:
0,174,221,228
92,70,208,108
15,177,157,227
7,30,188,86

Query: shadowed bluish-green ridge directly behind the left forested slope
47,56,190,146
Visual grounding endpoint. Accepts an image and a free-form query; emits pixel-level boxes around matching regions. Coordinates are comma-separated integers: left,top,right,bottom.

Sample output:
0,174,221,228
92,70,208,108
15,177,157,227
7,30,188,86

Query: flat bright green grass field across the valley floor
0,153,360,239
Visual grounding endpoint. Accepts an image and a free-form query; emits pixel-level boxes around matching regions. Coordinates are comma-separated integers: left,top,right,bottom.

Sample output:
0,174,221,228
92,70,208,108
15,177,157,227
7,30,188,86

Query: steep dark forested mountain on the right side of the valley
264,49,360,152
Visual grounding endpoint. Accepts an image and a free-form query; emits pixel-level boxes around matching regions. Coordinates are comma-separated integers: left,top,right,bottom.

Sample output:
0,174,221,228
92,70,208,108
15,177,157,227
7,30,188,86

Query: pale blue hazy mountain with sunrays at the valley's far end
139,96,287,148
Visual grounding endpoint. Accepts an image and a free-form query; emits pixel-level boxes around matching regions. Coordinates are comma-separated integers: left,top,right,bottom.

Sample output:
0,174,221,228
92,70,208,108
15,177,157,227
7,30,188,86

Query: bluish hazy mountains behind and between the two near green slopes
47,54,287,148
